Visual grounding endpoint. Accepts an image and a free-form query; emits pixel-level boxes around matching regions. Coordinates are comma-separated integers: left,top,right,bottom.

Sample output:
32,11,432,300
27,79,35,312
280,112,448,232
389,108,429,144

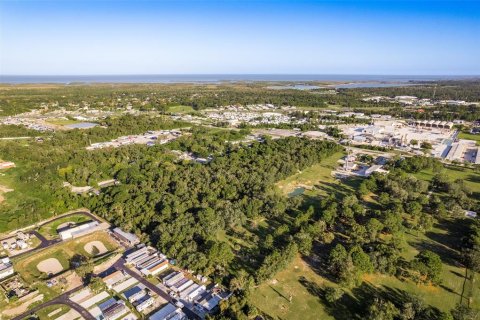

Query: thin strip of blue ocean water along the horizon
0,74,479,84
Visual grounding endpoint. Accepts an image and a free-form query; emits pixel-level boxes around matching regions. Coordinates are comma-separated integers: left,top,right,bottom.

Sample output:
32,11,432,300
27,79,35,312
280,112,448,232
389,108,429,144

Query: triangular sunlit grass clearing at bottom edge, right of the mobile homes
250,257,334,320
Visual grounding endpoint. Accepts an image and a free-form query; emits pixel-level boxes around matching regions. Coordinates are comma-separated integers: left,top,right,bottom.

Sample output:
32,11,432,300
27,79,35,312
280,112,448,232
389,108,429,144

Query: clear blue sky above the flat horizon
0,0,480,75
